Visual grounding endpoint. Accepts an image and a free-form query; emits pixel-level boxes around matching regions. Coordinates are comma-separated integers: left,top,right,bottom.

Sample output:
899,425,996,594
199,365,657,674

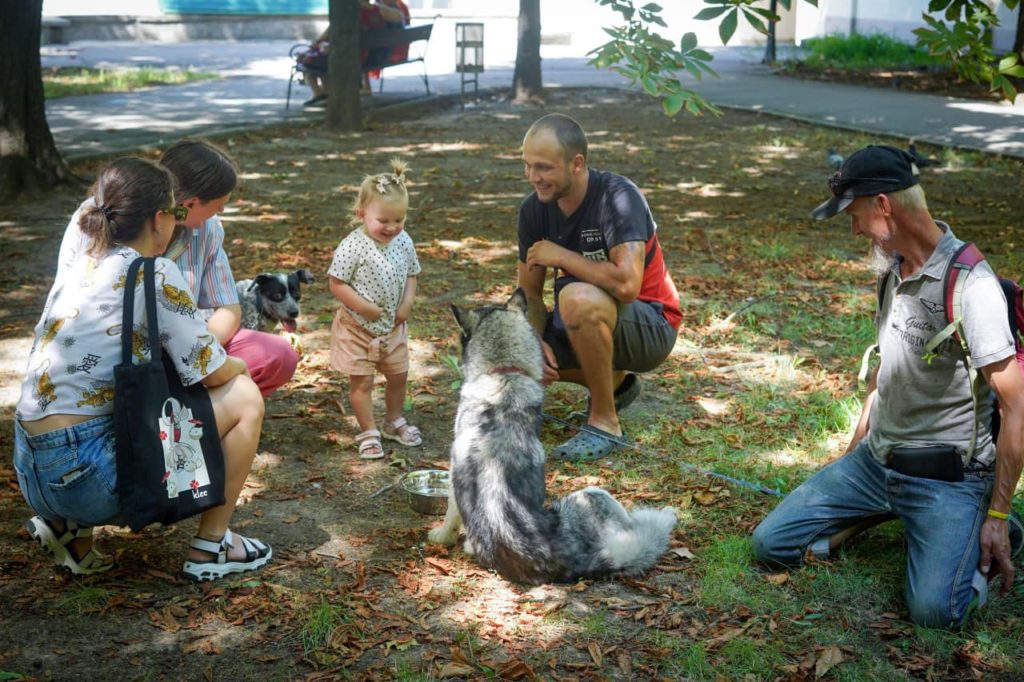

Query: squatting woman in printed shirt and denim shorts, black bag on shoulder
14,158,271,581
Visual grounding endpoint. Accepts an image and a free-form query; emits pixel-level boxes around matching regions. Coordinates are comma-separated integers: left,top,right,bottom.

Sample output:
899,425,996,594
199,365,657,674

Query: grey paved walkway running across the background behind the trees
43,41,1024,159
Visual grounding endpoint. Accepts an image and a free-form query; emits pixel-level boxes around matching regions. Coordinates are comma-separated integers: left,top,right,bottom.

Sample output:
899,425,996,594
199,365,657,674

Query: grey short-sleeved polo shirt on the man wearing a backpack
867,221,1015,464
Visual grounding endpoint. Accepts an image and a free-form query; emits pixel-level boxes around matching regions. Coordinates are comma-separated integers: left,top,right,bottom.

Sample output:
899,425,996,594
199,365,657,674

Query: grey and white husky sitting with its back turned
429,289,676,584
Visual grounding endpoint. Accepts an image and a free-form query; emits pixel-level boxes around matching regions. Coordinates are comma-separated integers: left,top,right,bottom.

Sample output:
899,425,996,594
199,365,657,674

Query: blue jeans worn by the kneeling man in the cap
754,441,994,628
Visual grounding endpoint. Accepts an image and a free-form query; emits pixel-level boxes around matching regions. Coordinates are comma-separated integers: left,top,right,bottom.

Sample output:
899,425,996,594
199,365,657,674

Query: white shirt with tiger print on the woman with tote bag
15,247,227,421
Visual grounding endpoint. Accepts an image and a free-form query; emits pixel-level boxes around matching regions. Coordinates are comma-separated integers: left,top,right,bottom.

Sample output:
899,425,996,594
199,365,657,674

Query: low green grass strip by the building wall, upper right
801,33,944,69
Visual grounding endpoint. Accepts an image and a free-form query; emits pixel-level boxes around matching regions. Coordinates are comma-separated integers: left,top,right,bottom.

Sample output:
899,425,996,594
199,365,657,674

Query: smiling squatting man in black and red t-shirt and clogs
518,114,682,459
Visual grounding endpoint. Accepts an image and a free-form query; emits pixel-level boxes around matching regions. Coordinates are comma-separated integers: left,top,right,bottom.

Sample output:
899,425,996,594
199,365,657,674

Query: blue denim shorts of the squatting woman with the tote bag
14,416,122,525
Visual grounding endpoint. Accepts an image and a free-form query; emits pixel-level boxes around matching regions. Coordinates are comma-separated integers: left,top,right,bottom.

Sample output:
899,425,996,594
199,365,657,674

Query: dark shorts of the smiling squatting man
544,280,677,372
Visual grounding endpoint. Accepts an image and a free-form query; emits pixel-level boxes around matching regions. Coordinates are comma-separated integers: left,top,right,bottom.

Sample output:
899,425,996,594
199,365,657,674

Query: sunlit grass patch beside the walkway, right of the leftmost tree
43,67,220,99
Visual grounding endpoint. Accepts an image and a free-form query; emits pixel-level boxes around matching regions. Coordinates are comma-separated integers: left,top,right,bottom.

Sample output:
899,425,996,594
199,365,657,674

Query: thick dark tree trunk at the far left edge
0,0,74,202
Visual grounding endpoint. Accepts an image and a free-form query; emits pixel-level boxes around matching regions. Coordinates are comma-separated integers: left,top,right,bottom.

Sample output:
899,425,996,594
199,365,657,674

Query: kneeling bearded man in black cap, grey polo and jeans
754,146,1024,628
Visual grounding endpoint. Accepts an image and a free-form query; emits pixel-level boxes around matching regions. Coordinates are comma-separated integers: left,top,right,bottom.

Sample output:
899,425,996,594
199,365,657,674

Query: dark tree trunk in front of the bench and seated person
327,0,362,131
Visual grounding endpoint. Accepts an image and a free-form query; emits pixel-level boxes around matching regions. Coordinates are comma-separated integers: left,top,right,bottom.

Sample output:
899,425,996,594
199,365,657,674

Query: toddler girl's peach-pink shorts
331,308,409,376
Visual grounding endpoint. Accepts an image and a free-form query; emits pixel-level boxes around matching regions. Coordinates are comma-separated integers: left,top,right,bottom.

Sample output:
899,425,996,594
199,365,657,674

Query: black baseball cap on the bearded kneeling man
811,144,921,220
